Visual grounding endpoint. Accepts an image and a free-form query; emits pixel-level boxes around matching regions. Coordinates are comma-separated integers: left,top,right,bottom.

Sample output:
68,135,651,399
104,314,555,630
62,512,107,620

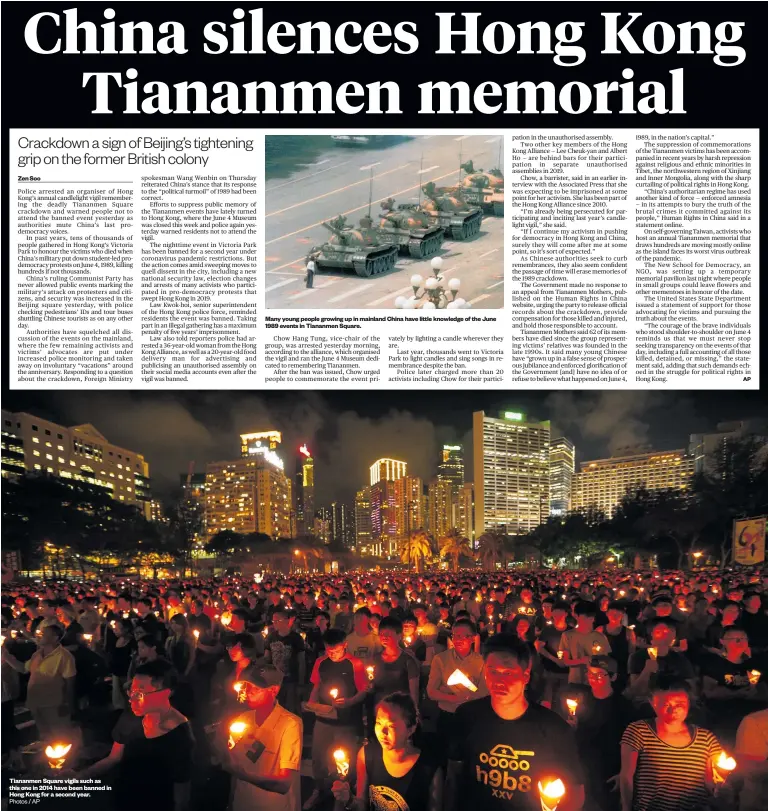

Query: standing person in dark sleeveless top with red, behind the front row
304,628,371,811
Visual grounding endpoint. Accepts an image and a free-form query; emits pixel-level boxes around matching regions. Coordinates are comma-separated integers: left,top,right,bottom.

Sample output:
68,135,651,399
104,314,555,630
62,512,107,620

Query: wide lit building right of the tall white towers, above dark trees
572,449,695,518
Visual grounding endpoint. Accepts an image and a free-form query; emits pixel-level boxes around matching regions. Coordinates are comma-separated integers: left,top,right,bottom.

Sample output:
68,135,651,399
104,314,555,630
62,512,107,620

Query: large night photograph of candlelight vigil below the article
0,390,768,811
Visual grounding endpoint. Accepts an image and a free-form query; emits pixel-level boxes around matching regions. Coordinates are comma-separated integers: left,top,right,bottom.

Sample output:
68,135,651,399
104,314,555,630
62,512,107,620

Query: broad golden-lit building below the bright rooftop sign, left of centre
205,449,291,540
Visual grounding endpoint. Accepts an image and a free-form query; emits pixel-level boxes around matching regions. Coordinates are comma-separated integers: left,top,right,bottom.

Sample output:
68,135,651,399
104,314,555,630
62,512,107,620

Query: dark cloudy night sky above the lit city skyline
3,391,767,506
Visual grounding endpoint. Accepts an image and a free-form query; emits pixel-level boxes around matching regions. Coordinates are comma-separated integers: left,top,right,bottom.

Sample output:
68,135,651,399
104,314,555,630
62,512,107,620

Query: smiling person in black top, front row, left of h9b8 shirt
332,693,443,811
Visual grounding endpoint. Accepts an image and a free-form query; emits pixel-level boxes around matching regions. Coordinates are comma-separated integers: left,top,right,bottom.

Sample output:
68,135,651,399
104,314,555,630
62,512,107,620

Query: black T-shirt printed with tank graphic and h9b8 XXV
449,696,584,811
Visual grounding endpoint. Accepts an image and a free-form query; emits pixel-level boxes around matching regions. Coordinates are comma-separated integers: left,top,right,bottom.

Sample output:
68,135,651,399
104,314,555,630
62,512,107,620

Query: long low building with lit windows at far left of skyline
2,410,151,518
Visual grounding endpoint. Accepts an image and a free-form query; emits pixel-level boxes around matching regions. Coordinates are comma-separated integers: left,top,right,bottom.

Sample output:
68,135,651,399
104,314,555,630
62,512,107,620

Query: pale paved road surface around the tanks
266,134,504,309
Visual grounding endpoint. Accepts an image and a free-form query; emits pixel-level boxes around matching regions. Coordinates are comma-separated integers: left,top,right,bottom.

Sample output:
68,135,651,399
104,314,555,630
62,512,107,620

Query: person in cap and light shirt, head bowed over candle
216,665,303,811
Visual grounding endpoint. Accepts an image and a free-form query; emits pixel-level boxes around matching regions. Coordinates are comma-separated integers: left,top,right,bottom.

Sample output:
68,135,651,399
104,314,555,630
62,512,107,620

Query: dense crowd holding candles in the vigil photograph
2,568,768,811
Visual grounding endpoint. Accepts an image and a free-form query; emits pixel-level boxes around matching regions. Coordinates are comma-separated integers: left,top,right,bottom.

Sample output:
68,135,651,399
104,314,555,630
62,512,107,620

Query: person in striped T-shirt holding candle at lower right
619,675,722,811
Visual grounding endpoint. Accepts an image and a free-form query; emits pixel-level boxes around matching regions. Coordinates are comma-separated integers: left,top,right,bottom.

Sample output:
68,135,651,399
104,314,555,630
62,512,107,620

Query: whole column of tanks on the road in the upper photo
307,161,504,279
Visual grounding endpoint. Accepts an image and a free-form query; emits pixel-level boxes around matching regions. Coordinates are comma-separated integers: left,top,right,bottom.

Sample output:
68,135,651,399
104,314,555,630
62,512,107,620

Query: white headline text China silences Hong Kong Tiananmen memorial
24,9,747,115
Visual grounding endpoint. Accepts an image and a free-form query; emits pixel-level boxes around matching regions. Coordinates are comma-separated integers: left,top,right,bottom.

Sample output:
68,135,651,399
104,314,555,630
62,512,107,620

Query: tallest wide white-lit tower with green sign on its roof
472,411,550,537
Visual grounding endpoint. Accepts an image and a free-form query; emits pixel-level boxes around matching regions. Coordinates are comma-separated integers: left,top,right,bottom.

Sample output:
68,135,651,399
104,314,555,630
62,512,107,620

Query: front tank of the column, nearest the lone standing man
309,215,398,279
